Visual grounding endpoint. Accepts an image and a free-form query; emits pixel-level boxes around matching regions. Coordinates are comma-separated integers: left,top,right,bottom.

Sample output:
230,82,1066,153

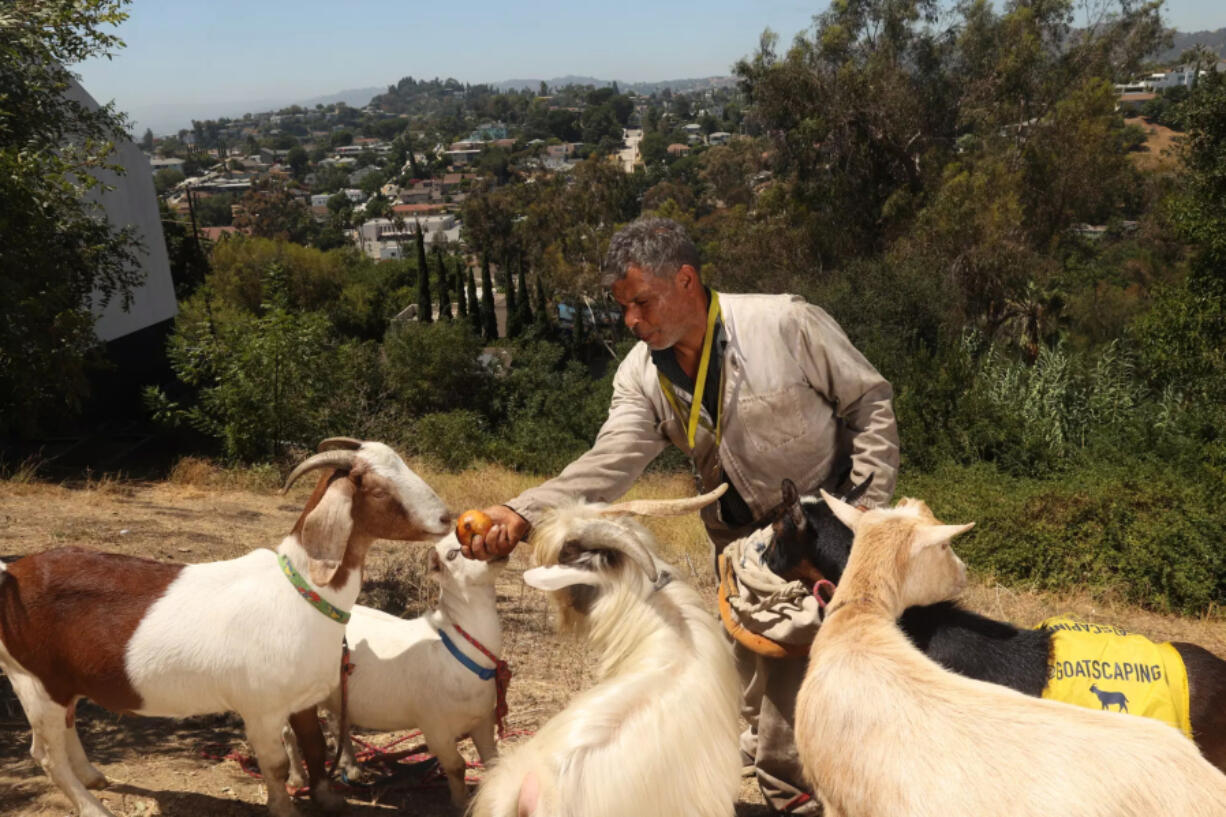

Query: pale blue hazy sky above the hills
75,0,1226,131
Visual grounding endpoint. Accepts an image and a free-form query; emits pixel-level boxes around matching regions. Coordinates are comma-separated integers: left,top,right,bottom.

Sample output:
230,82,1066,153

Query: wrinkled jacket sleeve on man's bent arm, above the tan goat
790,303,899,507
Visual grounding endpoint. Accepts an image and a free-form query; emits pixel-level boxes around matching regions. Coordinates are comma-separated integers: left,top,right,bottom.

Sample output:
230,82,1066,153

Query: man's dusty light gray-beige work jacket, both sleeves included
506,293,899,546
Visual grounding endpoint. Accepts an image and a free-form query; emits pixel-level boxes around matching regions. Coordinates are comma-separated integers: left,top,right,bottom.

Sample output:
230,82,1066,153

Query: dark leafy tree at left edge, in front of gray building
0,0,141,433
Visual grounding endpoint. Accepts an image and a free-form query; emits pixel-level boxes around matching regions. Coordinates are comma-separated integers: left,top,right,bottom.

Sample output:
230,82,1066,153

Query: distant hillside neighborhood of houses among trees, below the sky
141,77,743,261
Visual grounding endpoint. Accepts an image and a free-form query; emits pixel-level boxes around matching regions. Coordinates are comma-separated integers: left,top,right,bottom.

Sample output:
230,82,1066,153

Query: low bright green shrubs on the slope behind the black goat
899,461,1226,613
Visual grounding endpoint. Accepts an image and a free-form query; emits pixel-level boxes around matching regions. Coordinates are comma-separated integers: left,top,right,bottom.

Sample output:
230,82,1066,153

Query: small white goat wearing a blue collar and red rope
286,532,506,807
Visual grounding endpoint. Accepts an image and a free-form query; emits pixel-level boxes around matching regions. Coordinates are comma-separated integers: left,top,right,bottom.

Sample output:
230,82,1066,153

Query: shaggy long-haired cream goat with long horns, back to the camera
473,491,741,817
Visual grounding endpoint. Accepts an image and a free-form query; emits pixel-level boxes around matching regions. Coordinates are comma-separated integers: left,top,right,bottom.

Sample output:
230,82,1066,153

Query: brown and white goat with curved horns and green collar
0,438,450,817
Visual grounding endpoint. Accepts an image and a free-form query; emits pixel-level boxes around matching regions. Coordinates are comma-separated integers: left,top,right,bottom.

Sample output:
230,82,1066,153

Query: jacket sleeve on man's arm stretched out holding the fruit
506,347,668,526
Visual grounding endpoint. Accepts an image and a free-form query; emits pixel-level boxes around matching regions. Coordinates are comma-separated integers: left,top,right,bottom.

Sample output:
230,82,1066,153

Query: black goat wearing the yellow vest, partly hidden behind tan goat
763,476,1226,772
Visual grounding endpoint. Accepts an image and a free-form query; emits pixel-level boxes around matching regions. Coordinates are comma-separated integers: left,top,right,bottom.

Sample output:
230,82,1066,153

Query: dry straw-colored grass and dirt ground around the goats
0,462,1226,817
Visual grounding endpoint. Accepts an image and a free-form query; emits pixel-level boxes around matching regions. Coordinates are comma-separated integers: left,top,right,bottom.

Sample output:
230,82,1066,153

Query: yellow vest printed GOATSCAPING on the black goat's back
1036,615,1192,738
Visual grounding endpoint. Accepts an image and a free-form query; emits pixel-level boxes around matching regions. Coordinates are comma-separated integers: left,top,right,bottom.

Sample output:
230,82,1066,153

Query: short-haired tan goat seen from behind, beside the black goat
796,492,1226,817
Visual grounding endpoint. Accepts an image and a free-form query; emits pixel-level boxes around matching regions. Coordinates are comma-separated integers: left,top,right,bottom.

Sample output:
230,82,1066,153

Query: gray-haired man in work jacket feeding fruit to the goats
466,218,899,815
